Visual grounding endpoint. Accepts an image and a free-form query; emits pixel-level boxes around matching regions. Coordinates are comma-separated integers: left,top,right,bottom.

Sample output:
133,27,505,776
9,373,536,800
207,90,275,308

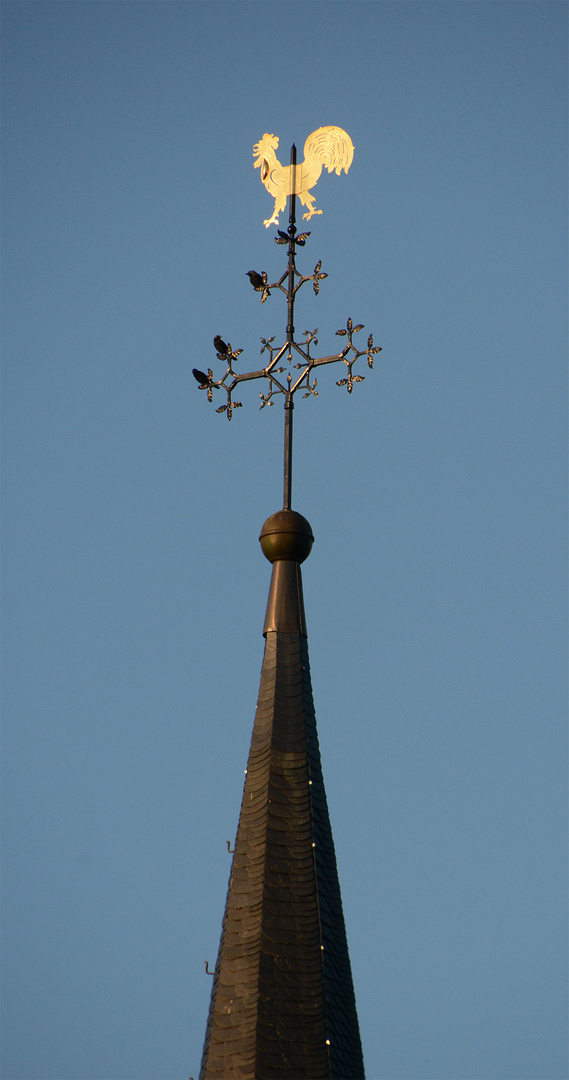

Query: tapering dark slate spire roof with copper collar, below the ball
200,512,364,1080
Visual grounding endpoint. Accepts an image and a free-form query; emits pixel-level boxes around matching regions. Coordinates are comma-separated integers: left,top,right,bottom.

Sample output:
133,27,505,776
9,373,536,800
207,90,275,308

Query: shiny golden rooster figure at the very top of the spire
253,127,354,228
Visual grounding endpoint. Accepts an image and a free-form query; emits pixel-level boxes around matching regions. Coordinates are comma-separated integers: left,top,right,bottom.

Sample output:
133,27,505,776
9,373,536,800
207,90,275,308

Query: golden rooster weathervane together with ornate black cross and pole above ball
192,127,381,510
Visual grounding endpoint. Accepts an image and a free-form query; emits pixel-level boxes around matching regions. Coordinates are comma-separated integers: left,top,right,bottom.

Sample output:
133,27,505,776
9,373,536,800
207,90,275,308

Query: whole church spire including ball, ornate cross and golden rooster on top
193,127,380,1080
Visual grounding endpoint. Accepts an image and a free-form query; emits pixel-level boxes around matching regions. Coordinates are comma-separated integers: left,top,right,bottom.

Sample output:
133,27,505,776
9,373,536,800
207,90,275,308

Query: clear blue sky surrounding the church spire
2,6,567,1080
